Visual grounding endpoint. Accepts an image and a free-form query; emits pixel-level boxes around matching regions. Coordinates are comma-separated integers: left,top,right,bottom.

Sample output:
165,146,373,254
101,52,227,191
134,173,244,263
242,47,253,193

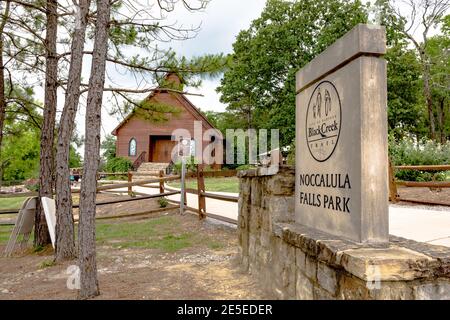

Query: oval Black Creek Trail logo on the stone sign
306,81,342,162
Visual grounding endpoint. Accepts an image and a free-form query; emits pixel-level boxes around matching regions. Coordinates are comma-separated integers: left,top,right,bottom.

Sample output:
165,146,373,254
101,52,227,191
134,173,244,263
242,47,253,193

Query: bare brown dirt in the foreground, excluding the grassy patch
0,215,268,299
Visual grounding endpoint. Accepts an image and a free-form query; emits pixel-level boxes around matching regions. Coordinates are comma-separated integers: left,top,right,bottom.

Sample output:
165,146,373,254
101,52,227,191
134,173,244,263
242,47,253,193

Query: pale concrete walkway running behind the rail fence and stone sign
108,187,450,247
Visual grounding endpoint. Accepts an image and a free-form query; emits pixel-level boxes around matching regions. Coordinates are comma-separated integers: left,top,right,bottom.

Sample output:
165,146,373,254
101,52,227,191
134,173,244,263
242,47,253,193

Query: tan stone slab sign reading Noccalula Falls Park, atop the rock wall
295,24,389,243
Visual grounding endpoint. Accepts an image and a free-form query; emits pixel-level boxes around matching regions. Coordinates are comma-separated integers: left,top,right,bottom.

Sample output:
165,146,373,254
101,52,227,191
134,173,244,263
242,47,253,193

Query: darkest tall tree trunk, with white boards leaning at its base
34,0,58,246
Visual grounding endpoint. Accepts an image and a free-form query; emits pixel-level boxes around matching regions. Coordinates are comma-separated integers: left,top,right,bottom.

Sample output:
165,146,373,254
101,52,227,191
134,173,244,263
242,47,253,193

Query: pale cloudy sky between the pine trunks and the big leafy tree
78,0,265,148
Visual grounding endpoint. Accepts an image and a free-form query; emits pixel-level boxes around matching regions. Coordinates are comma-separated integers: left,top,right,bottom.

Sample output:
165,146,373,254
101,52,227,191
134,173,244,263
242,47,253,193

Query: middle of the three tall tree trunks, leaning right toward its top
55,0,91,262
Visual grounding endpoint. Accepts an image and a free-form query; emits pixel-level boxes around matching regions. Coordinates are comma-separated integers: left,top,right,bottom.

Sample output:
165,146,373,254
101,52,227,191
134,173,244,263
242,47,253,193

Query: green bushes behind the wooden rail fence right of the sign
389,136,450,181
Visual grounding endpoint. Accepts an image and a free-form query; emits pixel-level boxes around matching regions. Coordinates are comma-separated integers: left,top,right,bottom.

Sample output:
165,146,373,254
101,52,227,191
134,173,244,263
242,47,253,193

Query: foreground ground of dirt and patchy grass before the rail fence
0,214,266,299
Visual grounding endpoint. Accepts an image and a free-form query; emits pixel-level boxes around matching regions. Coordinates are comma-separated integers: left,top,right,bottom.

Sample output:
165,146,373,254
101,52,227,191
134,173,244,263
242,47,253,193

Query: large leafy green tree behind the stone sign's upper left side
217,0,367,145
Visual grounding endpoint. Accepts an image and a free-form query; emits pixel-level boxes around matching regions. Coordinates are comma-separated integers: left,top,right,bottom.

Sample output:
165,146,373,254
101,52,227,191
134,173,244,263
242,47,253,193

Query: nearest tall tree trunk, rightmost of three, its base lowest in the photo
78,0,111,299
